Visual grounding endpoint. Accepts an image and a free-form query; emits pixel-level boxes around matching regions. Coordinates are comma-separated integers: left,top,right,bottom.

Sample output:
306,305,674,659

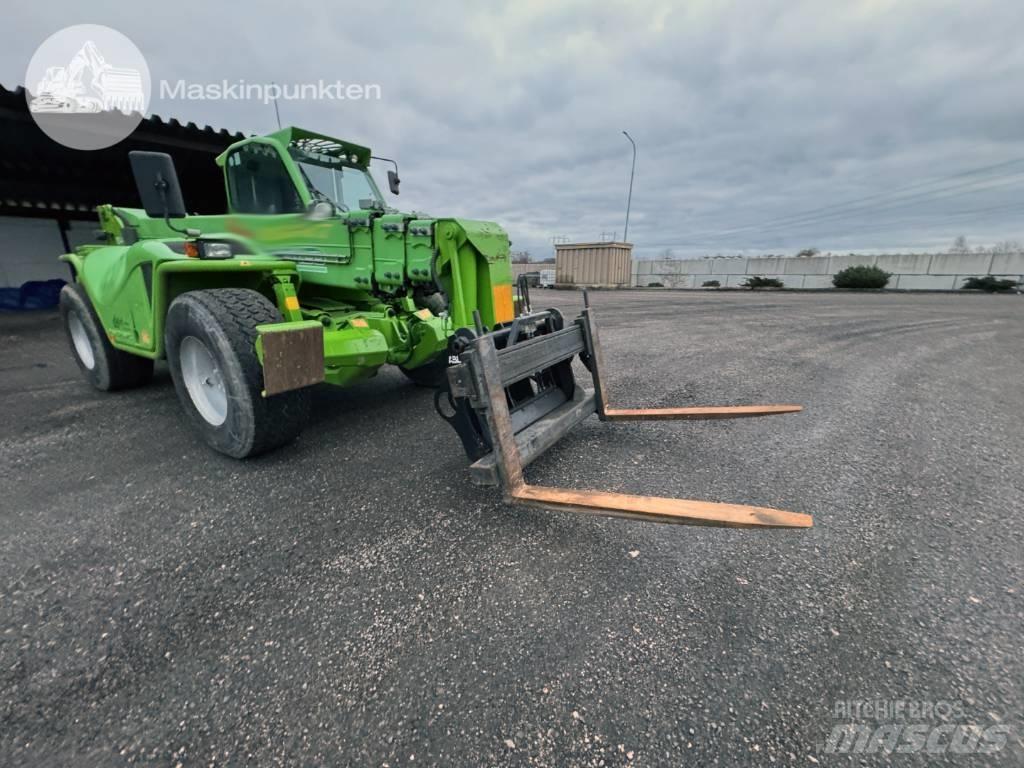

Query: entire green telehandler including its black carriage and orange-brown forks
60,127,811,527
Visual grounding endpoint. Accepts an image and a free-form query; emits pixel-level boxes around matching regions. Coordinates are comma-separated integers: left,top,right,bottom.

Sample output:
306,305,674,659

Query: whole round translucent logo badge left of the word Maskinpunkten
25,24,151,150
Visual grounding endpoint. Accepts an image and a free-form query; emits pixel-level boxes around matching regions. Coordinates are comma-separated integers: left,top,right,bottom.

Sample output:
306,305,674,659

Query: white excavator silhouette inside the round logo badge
29,40,145,115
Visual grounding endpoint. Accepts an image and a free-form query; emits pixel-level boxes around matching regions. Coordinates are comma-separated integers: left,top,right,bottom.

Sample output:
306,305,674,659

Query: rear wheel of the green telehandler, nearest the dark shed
60,283,153,392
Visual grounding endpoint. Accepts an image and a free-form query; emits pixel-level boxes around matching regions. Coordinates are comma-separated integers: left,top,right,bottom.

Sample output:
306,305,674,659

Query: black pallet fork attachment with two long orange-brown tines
435,292,813,527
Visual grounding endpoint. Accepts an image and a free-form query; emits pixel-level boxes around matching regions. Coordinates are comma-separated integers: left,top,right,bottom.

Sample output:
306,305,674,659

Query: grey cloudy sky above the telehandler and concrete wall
0,0,1024,258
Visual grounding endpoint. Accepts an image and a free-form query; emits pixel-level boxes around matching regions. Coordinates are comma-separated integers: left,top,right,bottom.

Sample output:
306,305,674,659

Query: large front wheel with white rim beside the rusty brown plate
165,288,310,459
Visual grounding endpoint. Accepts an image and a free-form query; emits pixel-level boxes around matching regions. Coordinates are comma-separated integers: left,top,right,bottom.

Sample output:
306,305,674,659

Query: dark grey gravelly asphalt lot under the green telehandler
0,292,1024,766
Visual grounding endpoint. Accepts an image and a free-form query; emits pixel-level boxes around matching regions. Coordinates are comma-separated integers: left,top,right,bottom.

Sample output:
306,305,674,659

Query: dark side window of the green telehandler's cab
226,143,303,214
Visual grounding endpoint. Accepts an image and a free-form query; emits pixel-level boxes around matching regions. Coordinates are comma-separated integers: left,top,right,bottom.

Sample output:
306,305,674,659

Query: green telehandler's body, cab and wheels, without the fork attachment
60,128,513,458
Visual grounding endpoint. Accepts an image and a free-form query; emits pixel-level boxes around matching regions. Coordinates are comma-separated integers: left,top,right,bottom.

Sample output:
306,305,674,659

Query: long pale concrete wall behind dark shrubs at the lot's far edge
633,253,1024,291
